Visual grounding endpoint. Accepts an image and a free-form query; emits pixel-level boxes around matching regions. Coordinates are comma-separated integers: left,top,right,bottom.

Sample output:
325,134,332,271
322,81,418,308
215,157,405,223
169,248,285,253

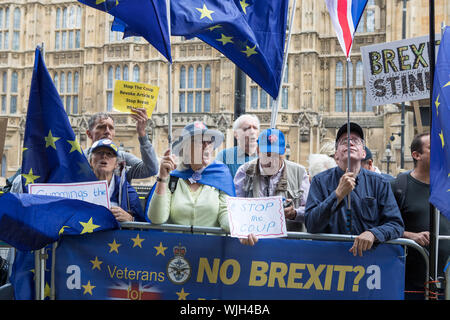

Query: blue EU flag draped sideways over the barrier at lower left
0,192,119,251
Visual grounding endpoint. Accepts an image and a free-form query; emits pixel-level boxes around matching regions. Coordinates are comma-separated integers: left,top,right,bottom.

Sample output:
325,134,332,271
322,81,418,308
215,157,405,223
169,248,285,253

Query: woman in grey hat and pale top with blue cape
146,122,235,226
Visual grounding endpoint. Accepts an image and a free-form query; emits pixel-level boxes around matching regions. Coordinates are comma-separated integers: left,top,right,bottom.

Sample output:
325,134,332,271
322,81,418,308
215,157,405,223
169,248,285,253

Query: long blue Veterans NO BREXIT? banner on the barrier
55,230,405,300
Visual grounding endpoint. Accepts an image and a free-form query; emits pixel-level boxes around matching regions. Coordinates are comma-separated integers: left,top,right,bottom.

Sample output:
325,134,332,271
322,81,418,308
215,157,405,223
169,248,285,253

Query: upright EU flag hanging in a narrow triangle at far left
22,49,98,192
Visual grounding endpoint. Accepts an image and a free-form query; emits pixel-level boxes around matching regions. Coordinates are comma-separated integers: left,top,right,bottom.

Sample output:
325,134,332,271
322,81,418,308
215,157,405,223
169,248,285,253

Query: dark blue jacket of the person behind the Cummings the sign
109,175,146,222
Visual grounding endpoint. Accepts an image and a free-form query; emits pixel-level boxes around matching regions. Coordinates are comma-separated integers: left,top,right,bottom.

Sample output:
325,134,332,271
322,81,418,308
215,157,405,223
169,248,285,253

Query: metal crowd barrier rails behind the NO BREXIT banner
29,222,429,300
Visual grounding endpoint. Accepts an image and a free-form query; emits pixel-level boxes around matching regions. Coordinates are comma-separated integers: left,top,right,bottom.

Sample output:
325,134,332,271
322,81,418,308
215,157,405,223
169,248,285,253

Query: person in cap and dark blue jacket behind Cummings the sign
89,139,145,222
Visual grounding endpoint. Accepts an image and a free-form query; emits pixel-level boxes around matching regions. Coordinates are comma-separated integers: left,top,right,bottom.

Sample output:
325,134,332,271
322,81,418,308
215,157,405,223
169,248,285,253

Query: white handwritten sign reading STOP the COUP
227,196,287,238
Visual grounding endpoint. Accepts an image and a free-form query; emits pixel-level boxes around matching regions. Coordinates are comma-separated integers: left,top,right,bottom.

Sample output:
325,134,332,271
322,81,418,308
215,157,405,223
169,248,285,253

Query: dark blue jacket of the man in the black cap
305,167,404,242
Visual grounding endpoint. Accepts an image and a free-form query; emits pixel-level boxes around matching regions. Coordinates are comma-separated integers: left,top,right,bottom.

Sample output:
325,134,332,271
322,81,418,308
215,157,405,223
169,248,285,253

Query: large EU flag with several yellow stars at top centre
170,0,289,99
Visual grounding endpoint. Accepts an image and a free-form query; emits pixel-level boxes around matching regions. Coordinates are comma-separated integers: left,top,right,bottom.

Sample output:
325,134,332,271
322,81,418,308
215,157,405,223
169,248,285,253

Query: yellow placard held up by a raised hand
113,80,159,118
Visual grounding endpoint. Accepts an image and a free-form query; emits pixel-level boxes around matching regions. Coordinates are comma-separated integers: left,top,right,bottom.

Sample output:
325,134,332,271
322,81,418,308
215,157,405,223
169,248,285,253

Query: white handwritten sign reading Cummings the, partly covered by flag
28,180,109,208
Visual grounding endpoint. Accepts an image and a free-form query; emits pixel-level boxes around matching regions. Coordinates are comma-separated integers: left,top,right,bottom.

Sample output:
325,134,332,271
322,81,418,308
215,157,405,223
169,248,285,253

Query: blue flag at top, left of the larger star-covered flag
78,0,172,62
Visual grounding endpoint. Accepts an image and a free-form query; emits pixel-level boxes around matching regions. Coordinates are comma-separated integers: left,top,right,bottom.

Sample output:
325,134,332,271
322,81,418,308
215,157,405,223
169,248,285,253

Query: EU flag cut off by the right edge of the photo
430,27,450,219
